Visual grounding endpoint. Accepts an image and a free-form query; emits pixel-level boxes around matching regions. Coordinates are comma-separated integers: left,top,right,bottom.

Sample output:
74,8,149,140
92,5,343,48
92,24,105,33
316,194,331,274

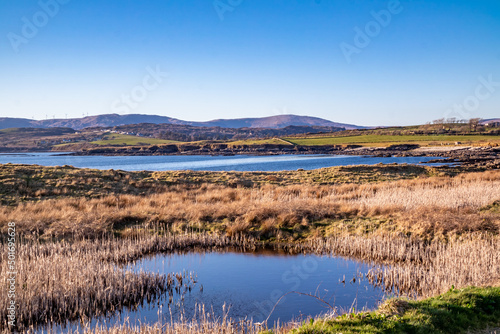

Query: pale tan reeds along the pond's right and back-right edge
282,234,500,297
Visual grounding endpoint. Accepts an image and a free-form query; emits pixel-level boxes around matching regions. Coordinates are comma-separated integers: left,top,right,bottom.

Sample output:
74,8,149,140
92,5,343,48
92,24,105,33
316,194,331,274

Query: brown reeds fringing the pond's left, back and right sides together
0,231,500,333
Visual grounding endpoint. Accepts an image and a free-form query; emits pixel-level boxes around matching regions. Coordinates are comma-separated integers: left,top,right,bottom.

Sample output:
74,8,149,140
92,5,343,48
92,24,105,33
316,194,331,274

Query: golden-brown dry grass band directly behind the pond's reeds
0,171,500,237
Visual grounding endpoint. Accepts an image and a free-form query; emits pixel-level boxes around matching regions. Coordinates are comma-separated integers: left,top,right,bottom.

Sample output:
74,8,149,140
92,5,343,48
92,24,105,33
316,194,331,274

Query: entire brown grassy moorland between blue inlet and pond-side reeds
0,165,500,241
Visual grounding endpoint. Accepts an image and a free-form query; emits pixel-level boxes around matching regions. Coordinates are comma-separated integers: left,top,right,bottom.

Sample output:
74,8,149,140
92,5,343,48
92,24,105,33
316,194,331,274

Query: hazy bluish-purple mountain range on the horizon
0,114,366,130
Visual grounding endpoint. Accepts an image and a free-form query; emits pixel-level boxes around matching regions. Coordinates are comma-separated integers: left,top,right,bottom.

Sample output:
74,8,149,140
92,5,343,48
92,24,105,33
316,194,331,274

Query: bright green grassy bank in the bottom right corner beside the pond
291,287,500,334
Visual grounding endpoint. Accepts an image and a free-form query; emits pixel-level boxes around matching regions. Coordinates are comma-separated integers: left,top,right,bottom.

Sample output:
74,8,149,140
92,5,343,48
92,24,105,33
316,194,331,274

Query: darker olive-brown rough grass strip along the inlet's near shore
0,164,446,205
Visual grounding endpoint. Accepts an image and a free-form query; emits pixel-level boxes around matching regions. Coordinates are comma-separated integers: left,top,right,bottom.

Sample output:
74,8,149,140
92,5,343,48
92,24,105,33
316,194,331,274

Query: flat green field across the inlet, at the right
284,135,500,146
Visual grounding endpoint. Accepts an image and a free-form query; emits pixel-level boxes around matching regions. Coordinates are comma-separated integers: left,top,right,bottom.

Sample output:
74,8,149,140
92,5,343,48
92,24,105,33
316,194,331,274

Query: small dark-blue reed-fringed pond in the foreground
91,251,384,324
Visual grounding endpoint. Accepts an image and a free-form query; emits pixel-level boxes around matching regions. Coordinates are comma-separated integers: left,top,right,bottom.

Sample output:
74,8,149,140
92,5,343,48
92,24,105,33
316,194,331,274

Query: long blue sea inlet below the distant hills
0,153,448,171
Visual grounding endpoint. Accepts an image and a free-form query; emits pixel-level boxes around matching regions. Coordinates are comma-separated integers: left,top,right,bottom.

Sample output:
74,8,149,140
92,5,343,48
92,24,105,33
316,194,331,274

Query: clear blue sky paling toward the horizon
0,0,500,125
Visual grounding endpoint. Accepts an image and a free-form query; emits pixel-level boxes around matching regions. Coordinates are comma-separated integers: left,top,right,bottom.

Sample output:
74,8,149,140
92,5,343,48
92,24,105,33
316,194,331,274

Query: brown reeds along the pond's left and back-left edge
0,235,250,330
